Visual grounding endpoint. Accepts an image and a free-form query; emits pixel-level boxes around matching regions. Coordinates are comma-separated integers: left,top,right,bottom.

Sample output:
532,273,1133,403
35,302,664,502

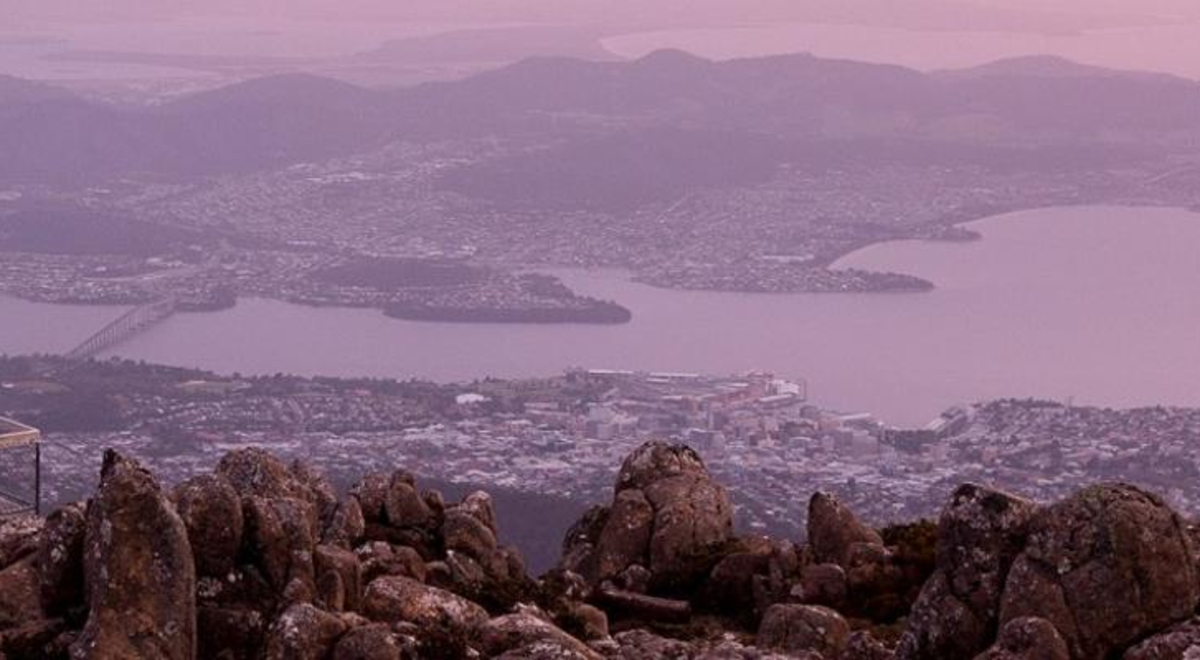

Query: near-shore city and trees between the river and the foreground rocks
7,358,1200,568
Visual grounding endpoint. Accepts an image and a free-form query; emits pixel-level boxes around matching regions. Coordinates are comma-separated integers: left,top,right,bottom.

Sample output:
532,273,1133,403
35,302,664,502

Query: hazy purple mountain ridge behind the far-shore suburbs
0,50,1200,182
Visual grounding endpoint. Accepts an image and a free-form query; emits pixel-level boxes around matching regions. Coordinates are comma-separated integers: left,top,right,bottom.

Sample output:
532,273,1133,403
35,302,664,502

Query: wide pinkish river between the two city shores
0,208,1200,425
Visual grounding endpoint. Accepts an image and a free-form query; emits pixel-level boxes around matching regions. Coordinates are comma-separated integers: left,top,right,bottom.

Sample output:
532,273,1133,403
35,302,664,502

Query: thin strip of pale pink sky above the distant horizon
7,0,1200,28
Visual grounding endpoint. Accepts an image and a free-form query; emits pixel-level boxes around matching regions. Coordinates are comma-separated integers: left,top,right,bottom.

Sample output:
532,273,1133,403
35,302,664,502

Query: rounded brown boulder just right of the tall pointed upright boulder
173,474,244,577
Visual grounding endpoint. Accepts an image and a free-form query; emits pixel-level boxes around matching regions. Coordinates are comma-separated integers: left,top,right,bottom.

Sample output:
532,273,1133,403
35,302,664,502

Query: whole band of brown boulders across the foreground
0,443,1200,660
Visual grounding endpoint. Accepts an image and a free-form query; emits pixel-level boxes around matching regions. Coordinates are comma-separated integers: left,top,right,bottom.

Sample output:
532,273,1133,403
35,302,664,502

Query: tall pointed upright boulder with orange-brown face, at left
72,450,196,660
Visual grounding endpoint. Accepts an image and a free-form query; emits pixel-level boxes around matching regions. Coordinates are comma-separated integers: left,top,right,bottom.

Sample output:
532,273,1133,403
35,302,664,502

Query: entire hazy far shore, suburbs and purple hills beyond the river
7,52,1200,323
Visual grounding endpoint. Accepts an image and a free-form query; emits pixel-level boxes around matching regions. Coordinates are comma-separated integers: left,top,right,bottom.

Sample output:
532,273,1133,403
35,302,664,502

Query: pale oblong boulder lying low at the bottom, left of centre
362,576,487,634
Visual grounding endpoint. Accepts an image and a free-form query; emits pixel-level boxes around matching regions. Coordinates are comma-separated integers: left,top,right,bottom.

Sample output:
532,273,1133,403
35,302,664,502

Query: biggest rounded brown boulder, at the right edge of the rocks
1000,484,1200,660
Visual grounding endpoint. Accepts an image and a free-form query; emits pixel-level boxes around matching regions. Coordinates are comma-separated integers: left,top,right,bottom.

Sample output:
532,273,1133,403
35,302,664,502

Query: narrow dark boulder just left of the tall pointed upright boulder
37,504,88,616
